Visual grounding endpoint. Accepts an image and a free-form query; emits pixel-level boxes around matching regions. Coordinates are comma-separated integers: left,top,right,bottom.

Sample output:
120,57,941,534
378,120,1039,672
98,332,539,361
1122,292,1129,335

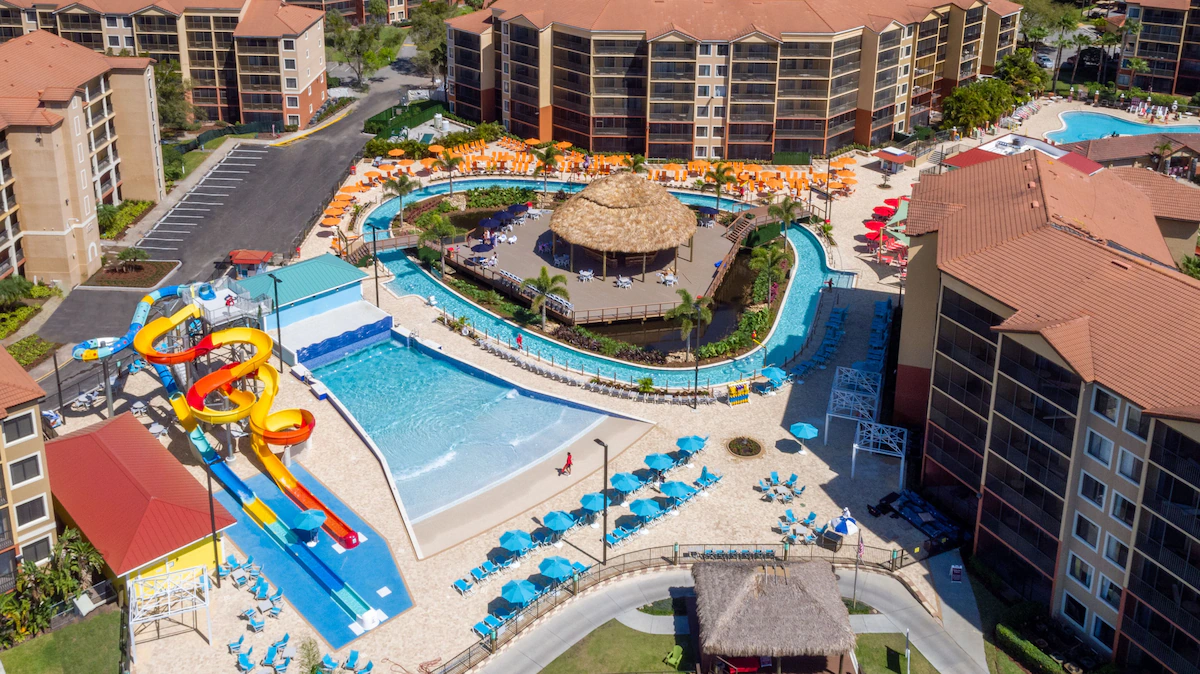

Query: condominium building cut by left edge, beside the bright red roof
0,349,55,592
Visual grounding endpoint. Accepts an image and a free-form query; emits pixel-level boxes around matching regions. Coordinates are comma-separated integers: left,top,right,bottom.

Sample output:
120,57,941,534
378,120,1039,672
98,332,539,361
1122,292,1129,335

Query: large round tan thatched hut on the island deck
550,173,696,281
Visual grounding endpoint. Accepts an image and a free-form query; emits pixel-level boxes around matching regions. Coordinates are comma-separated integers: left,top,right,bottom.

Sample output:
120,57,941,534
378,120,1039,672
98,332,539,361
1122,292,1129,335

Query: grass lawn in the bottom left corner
0,610,121,674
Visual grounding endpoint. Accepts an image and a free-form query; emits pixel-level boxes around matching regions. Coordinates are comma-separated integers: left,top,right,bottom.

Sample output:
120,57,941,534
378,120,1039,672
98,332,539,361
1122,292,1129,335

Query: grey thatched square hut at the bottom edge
691,561,854,674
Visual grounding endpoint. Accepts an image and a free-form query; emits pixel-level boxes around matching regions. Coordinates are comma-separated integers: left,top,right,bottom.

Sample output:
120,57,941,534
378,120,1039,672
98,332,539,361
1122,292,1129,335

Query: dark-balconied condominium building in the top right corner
1116,0,1200,96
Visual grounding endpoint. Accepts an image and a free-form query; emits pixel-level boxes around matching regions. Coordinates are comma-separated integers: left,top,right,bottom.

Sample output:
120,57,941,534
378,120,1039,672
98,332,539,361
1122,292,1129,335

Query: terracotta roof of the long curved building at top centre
472,0,1007,40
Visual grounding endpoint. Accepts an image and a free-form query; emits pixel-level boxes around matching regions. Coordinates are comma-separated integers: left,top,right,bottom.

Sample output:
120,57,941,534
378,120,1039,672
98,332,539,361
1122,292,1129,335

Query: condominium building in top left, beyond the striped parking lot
0,0,328,131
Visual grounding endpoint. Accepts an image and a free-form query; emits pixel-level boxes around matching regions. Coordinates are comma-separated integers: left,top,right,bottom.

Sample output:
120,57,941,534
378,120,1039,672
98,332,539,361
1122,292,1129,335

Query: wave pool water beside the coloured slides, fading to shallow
313,341,606,522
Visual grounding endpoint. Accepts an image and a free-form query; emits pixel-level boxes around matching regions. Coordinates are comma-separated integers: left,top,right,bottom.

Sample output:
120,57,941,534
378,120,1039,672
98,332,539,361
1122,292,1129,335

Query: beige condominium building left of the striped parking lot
0,31,166,288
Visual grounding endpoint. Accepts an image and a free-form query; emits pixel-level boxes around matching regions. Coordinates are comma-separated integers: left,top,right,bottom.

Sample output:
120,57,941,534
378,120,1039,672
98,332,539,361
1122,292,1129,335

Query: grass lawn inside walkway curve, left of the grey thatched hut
541,620,700,674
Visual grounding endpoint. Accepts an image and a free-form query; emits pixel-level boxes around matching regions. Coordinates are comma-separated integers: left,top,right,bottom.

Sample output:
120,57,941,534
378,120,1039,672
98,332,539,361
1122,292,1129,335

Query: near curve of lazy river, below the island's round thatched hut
374,223,844,386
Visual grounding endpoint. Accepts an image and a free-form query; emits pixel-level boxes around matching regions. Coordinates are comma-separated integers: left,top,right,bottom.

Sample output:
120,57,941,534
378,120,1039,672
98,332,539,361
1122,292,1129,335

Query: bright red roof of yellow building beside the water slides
46,414,236,576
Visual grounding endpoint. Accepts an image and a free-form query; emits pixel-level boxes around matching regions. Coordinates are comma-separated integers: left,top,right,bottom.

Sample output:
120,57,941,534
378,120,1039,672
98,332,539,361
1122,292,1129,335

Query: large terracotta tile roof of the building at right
908,154,1200,420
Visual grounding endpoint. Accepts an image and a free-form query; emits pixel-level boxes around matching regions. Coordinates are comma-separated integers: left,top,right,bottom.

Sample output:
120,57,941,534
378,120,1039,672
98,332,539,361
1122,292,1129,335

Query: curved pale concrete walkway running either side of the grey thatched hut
484,553,988,674
